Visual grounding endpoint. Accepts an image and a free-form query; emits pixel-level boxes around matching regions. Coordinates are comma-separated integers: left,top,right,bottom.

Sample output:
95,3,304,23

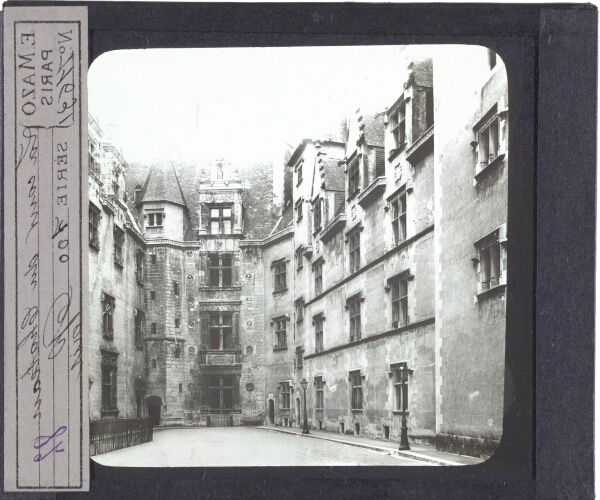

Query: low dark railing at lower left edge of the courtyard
90,418,152,456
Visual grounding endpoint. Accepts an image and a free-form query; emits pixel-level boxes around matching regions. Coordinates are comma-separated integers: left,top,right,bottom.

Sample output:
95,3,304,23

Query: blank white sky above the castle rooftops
88,46,432,165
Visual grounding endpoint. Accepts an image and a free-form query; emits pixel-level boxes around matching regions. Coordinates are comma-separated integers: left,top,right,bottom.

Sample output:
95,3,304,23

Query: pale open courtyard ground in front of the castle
92,427,432,467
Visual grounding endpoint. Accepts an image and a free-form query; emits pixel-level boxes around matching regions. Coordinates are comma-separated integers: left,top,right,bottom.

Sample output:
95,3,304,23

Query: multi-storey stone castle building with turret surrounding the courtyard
89,46,508,456
